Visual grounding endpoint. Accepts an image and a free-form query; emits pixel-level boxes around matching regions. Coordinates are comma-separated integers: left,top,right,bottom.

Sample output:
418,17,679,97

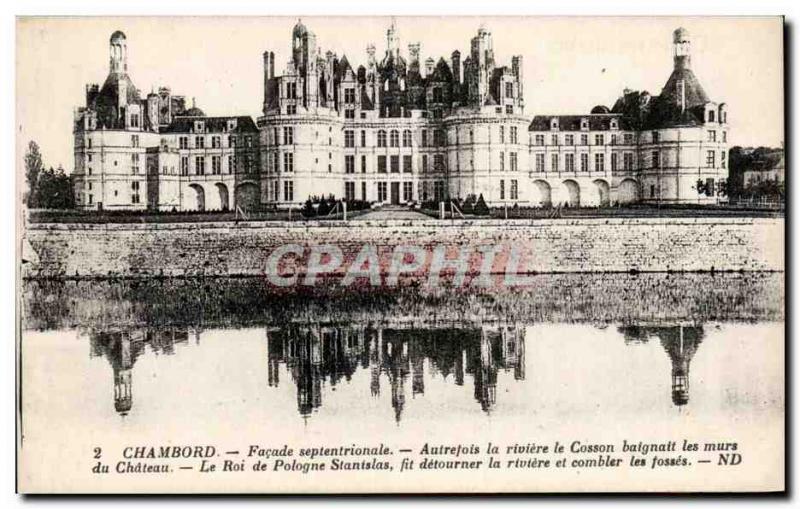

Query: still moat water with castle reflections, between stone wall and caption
21,273,784,442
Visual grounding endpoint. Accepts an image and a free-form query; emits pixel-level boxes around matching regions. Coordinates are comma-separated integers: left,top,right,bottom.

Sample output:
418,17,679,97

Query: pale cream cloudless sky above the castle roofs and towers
16,16,784,172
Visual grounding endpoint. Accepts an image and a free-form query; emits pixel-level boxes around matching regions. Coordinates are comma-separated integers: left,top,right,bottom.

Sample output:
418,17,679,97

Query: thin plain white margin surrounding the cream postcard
0,0,800,507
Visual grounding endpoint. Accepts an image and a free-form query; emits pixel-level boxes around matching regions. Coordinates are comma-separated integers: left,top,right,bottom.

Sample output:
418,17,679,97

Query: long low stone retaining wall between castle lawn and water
22,218,784,283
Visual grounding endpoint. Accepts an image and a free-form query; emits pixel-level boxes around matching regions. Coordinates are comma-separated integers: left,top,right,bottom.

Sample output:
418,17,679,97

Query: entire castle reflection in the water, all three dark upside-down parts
89,324,703,416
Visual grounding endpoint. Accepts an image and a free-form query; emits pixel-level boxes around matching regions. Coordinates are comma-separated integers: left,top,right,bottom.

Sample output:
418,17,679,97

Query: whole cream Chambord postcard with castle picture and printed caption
15,16,786,494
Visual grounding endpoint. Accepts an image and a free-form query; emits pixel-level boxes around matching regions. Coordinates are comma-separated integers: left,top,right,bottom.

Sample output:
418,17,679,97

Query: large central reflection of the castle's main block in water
268,325,525,421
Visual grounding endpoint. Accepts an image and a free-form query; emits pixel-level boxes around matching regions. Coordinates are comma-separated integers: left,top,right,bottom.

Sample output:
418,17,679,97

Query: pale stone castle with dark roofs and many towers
73,21,729,210
